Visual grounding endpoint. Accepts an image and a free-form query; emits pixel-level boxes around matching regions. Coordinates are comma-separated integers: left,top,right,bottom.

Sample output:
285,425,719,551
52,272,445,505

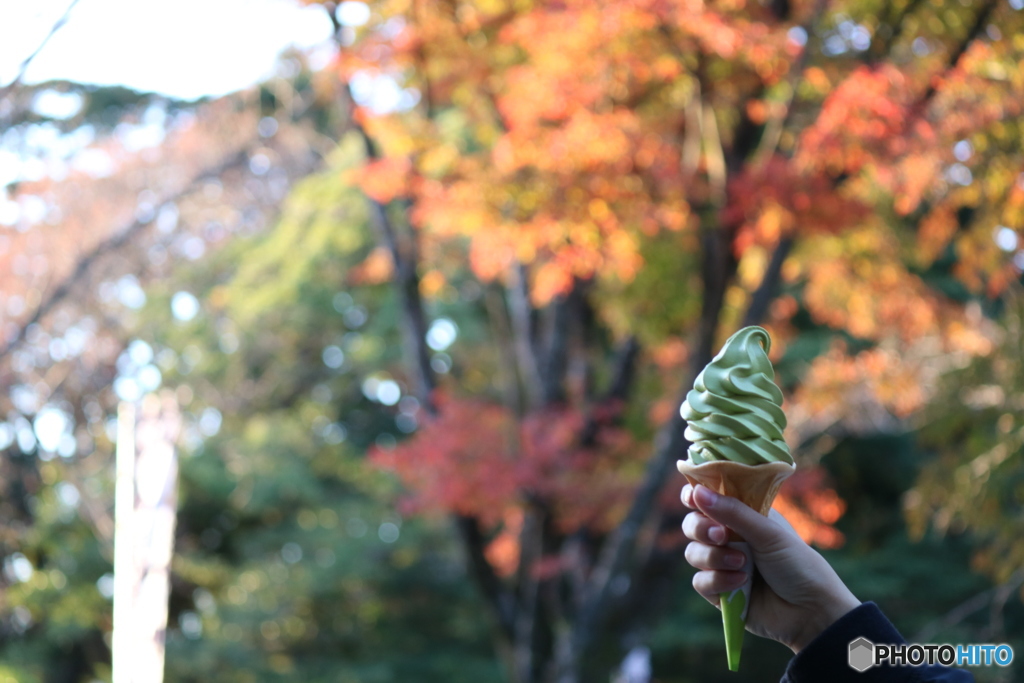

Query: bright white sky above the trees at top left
0,0,333,99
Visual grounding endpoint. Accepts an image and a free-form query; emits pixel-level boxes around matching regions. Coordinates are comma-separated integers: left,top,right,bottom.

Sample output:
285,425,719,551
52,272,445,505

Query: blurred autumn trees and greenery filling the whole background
0,0,1024,683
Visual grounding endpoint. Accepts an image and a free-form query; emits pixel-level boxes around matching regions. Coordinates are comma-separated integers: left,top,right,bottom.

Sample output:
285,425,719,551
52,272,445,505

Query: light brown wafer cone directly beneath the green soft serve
676,460,797,541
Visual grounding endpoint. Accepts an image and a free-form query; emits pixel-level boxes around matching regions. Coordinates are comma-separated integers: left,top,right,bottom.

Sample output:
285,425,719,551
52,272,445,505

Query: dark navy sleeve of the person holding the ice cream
781,602,974,683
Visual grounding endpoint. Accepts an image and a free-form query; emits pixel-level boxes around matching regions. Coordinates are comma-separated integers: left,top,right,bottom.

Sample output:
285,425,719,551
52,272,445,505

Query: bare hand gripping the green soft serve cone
682,484,860,652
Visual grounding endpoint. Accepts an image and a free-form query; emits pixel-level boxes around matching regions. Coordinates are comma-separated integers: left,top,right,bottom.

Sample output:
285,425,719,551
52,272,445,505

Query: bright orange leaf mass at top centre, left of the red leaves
354,2,806,304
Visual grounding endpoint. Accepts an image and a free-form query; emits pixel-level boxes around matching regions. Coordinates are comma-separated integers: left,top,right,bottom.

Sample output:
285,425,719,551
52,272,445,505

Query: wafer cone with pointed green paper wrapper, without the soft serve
676,460,797,671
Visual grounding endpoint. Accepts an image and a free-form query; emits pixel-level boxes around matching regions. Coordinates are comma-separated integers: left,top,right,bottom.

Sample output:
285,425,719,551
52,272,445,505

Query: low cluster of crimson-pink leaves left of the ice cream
371,395,637,532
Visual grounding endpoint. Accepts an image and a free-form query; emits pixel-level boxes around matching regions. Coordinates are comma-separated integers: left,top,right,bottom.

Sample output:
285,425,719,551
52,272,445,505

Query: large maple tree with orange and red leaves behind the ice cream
303,0,1024,682
